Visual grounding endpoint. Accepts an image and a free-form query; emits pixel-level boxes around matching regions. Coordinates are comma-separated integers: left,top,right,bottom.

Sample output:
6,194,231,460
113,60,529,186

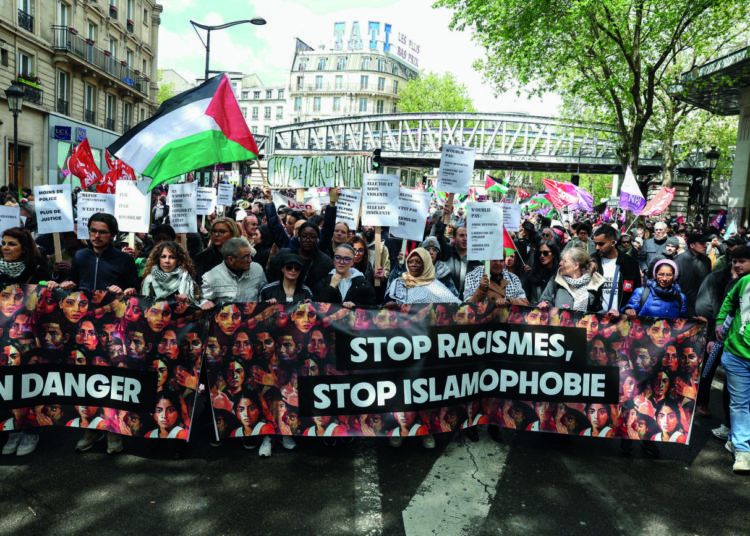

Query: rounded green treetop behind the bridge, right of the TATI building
398,72,475,113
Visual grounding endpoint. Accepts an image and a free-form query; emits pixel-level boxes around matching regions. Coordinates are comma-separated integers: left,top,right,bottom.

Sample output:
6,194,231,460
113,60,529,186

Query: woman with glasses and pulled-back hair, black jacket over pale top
313,244,377,309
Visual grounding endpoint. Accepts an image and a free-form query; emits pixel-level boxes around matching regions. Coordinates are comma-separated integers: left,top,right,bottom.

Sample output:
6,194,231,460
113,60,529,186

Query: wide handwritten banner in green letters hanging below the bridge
268,154,372,188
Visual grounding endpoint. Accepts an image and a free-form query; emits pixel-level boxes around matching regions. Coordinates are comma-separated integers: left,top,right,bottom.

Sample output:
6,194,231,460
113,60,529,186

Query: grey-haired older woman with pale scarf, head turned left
537,247,604,313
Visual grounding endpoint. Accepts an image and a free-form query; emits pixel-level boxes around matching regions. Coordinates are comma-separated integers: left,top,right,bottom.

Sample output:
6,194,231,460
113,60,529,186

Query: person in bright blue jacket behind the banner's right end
623,259,687,320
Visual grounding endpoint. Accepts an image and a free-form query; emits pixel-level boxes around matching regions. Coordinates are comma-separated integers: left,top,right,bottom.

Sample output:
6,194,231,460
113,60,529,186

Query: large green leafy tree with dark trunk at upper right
435,0,750,173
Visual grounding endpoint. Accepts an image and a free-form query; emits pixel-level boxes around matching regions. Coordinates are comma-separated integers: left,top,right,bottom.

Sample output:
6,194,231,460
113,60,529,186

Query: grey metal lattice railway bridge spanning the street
256,112,688,175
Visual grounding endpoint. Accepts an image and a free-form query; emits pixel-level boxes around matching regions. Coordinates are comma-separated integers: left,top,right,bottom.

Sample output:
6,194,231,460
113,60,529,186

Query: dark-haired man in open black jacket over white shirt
594,225,641,313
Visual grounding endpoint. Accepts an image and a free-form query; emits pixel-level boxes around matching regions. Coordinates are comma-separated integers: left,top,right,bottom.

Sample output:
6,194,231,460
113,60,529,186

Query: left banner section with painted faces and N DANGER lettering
0,285,205,439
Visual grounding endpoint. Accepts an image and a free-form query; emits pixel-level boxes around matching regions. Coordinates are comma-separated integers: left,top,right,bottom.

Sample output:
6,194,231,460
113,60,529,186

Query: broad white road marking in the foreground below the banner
403,433,509,536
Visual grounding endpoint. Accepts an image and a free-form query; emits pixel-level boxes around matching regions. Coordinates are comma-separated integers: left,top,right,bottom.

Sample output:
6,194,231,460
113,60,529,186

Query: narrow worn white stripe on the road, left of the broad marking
354,441,383,536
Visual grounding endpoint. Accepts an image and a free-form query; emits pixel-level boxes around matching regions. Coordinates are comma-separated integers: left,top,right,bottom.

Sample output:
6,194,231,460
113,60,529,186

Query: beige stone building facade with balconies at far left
0,0,162,187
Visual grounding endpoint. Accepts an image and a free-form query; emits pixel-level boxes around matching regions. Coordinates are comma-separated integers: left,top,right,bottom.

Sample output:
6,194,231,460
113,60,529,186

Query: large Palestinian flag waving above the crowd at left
108,74,258,188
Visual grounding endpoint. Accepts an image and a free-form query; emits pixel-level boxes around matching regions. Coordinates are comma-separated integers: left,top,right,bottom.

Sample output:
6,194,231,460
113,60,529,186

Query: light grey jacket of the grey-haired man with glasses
201,262,268,304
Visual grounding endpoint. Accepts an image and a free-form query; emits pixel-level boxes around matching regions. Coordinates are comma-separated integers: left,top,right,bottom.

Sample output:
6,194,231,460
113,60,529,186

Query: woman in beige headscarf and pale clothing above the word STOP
385,248,460,309
